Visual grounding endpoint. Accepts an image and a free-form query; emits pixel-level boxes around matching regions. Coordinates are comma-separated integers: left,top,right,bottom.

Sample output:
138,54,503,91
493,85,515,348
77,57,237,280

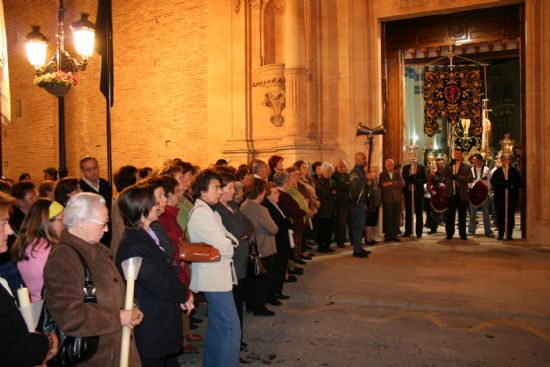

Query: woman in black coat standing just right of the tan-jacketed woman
262,182,292,304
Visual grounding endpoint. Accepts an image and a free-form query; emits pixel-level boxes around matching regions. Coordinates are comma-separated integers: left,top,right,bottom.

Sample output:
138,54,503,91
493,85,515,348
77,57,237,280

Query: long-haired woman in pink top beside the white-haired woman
11,199,63,302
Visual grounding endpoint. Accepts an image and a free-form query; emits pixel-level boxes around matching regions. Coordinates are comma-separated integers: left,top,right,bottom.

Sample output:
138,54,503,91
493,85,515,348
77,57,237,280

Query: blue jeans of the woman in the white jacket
202,291,241,367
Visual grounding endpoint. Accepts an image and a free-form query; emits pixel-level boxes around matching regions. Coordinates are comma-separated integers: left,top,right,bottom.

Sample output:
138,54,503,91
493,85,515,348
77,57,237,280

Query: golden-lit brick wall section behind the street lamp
2,0,212,182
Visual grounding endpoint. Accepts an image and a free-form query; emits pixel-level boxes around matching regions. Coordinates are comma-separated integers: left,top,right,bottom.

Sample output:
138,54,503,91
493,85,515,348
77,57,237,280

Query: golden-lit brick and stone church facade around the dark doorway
2,0,550,244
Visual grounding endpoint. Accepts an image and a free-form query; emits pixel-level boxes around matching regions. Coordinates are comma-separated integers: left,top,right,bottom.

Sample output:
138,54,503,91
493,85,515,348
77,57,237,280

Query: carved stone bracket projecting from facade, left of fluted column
252,64,286,127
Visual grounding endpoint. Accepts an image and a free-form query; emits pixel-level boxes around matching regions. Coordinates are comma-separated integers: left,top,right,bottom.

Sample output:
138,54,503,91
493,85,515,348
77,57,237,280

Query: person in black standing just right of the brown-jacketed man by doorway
402,158,427,238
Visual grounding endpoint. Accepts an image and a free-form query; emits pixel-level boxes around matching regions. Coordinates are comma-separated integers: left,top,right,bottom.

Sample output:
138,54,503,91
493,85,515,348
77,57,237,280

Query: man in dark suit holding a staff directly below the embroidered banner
442,148,474,240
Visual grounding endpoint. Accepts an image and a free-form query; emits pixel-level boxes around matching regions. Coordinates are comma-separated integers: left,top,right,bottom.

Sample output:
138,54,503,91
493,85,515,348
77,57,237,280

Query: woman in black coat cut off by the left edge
0,192,57,367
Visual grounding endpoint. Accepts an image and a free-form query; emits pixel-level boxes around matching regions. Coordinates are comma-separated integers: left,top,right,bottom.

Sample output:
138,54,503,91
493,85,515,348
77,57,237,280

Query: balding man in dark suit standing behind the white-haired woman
78,156,113,247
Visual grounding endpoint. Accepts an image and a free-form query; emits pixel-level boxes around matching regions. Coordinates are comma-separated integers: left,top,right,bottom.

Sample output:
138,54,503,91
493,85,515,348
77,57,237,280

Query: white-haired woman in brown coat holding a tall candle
44,193,143,367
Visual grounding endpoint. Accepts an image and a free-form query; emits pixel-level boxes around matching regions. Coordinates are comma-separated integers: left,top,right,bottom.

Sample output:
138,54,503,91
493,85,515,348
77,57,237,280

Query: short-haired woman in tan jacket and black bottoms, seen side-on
241,178,281,316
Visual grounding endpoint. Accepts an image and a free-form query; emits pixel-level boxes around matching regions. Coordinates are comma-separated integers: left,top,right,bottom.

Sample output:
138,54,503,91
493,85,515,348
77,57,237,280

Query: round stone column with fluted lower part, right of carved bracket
284,0,308,139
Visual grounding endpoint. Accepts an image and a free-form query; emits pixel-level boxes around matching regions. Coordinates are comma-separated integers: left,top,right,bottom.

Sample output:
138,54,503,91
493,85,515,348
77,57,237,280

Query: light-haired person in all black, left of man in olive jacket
315,162,336,253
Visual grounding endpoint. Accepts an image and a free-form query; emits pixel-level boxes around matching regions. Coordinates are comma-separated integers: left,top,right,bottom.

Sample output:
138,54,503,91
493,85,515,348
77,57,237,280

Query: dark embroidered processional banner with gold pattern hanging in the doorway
424,70,483,152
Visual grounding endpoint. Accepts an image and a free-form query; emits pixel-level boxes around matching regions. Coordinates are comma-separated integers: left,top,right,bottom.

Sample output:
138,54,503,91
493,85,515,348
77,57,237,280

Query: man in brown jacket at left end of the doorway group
379,159,403,242
